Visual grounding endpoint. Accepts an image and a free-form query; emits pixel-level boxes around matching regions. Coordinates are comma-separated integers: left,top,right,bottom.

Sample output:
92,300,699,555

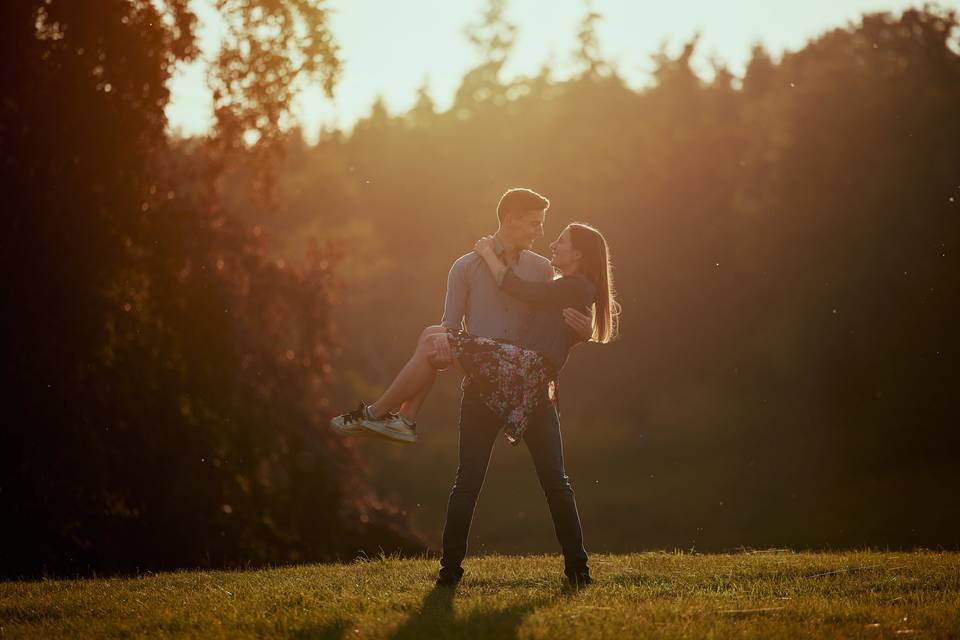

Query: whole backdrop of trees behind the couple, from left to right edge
0,0,960,575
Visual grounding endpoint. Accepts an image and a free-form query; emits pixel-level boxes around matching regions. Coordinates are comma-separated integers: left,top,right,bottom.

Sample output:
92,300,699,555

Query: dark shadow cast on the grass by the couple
389,587,553,640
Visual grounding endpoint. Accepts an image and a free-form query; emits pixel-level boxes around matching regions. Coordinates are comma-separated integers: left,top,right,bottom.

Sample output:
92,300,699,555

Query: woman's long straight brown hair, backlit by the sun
568,222,620,343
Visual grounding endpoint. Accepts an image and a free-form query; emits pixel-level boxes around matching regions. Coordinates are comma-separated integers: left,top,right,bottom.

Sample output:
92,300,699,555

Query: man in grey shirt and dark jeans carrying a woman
433,189,593,586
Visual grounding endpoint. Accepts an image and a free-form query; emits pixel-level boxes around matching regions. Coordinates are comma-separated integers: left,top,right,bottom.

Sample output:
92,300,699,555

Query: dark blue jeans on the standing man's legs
440,388,587,576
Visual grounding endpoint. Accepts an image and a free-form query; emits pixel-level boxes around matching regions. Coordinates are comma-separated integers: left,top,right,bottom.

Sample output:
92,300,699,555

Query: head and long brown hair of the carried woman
564,222,620,342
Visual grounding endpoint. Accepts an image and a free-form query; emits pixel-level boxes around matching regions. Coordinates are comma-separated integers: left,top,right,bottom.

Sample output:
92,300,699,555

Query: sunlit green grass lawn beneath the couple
0,550,960,640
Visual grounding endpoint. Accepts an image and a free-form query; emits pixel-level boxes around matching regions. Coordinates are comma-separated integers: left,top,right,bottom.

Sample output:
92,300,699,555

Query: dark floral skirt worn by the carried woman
450,331,557,445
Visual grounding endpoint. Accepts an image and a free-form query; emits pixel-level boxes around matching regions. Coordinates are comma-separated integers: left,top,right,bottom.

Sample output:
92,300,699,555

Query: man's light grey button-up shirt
440,244,553,342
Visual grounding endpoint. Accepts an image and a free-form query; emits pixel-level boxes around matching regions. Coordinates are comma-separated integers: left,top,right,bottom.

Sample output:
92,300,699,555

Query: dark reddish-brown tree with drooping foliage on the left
0,0,421,575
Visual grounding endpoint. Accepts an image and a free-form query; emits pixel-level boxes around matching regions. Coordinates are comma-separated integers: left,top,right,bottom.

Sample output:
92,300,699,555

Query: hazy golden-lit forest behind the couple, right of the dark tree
225,7,960,551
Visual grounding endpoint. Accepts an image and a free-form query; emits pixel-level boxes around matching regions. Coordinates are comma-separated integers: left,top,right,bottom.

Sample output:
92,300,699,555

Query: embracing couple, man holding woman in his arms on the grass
330,189,619,586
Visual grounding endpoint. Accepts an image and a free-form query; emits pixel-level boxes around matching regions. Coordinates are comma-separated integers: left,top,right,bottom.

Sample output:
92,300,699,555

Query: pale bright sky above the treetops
167,0,960,139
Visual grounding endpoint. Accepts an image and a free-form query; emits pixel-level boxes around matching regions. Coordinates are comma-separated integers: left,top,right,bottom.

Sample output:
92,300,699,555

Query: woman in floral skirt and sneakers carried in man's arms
330,223,619,444
